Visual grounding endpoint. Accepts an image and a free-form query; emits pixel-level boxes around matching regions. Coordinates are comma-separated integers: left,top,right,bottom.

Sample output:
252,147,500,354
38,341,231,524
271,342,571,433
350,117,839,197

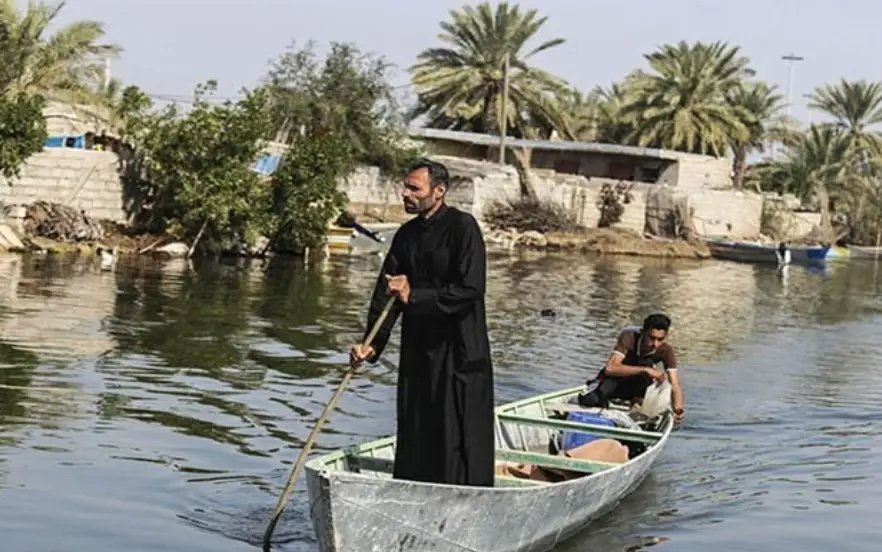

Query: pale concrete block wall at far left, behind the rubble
0,148,126,222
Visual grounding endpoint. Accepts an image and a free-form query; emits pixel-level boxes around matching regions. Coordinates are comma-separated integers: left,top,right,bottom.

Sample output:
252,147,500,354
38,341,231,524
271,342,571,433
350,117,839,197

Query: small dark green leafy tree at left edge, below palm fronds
0,94,47,179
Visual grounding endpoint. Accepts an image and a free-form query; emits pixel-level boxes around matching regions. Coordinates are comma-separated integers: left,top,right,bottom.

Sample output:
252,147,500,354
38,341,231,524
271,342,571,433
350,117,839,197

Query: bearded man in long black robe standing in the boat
350,159,496,486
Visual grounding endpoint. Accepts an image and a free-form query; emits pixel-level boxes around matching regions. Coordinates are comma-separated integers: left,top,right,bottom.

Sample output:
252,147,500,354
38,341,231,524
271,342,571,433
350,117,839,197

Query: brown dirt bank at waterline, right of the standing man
485,228,710,259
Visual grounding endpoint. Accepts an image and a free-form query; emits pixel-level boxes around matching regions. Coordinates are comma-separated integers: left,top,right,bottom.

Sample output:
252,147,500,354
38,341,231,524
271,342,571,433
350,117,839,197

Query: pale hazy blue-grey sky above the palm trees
46,0,882,125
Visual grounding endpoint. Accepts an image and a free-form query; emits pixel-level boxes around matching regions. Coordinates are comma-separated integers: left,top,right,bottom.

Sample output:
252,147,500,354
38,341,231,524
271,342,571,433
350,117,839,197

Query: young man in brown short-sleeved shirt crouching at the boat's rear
579,314,684,424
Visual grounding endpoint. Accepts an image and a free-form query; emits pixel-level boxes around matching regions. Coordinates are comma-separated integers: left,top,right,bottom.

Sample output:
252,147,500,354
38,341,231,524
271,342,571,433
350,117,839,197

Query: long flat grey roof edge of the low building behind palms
408,128,680,161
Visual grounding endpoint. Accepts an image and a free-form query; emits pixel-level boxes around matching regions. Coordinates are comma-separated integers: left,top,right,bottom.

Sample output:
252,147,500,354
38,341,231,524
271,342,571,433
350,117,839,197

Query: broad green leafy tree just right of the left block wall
123,81,271,249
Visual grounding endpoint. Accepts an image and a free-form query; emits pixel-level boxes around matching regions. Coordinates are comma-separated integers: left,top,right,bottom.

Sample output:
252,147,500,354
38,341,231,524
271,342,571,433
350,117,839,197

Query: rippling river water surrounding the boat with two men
0,250,882,552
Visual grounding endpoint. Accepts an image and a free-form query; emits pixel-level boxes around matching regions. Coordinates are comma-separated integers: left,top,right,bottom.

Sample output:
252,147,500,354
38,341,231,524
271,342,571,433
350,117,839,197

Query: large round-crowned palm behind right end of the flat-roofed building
621,41,753,157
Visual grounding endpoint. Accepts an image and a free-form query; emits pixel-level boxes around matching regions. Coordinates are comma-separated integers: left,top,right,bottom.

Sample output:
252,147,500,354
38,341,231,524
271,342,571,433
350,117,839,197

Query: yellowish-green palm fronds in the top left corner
0,0,122,104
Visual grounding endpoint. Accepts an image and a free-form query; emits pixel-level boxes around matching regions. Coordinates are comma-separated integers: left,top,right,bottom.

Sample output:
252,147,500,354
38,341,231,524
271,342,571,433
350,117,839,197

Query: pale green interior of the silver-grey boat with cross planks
320,387,673,488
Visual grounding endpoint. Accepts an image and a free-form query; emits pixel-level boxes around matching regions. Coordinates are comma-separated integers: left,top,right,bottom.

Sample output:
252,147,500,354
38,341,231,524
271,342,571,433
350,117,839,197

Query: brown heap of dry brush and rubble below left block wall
22,201,104,242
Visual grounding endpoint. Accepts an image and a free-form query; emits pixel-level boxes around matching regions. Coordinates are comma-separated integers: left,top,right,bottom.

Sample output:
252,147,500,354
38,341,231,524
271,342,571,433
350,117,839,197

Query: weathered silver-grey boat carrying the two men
306,387,673,552
